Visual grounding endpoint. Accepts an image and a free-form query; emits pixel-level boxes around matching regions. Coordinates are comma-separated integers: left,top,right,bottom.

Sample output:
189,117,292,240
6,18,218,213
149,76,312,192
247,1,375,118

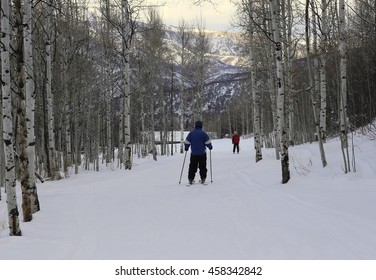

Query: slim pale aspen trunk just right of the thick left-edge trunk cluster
45,0,57,180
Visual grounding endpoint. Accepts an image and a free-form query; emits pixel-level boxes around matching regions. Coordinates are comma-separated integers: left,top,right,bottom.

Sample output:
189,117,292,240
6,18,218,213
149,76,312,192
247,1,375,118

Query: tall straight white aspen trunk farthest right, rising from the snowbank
339,0,350,173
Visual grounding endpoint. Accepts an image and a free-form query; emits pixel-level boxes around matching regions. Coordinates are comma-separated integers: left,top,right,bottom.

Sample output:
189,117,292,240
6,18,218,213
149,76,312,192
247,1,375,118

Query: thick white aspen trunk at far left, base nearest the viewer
0,0,22,236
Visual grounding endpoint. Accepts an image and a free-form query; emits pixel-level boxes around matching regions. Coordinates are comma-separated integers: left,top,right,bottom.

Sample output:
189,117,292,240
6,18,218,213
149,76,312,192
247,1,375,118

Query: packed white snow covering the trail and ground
0,132,376,260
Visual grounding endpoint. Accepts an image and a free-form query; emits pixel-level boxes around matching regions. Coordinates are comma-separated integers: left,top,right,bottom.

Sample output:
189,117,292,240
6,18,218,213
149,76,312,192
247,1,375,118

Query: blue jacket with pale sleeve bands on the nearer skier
184,123,213,155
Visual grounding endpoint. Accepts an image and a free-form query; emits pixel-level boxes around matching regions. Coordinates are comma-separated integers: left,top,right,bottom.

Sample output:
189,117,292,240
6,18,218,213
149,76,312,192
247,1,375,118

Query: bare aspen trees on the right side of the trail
227,0,376,183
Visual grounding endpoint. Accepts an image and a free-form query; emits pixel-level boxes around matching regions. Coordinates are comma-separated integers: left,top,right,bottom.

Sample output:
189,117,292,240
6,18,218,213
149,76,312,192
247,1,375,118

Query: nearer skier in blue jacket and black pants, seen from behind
184,121,213,184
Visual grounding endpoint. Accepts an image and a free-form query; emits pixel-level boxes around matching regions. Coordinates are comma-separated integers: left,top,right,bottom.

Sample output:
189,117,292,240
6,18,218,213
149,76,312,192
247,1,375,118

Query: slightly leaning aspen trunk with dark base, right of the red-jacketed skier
270,0,290,184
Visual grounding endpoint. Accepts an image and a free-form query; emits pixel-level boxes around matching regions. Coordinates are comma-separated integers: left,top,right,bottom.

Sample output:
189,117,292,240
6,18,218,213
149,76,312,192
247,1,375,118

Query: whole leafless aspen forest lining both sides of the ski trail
0,0,376,235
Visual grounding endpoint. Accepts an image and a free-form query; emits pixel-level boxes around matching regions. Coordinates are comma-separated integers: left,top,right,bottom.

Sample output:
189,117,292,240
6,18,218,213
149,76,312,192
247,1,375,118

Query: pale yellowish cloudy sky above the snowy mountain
148,0,235,31
